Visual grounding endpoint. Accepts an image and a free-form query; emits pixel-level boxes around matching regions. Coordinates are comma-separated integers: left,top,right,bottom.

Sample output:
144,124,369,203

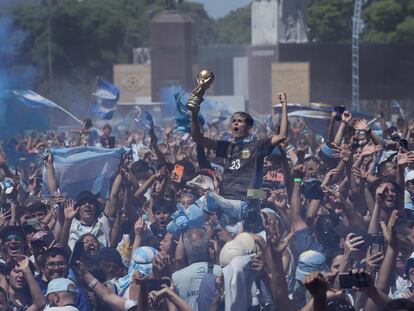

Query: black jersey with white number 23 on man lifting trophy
216,138,273,201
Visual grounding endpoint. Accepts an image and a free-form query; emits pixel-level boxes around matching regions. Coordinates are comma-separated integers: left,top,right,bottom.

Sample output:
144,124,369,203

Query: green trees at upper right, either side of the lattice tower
308,0,414,43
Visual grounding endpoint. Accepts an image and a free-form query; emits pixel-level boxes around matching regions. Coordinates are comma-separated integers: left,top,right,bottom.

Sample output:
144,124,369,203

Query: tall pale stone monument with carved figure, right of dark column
247,0,307,116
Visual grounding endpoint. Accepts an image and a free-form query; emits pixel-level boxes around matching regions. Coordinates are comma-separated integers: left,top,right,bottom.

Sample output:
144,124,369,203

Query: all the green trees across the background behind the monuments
13,0,414,90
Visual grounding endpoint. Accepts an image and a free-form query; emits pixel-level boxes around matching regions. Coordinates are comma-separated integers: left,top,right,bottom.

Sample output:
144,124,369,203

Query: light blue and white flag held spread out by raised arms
43,147,129,199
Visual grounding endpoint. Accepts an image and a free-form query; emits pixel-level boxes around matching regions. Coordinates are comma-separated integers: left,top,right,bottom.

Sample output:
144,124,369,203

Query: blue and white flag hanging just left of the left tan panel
92,77,119,120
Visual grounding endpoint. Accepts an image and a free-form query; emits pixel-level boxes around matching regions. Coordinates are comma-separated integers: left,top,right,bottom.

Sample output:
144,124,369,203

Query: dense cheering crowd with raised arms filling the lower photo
0,94,414,311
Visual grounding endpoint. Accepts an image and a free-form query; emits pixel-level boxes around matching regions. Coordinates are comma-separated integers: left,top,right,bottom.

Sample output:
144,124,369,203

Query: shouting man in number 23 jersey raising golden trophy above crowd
187,69,288,232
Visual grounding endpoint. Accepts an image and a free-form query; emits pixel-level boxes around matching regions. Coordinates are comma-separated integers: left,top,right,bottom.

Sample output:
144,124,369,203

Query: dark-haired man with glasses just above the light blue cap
36,247,90,311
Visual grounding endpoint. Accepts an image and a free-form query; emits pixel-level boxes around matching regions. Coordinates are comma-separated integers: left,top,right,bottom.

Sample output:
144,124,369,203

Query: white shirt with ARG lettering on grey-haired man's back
172,262,223,311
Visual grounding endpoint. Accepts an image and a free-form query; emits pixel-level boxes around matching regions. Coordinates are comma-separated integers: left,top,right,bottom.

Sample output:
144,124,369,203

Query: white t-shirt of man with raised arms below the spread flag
68,213,111,250
